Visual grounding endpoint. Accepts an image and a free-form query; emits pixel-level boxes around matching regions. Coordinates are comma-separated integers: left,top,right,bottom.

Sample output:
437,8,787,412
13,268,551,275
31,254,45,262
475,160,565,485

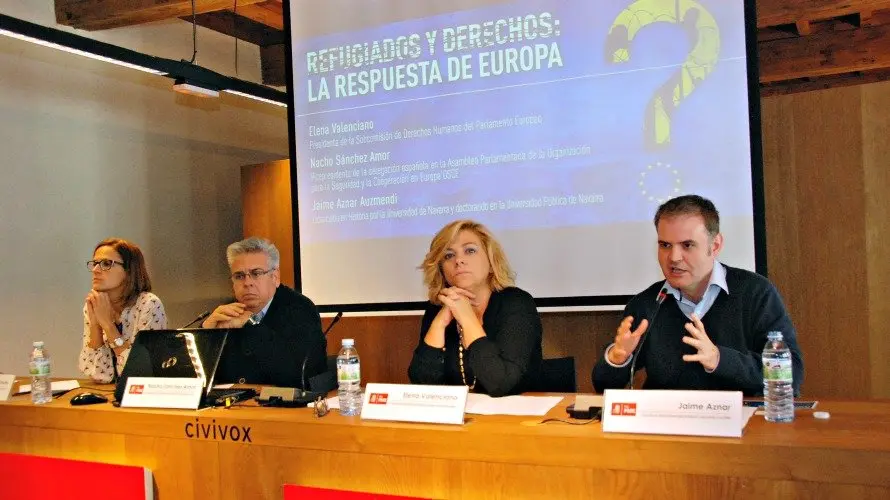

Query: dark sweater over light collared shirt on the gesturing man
592,263,803,396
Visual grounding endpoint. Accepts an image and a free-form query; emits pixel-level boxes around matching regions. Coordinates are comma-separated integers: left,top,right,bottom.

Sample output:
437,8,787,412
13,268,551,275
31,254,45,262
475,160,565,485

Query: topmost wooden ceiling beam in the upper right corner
757,0,890,28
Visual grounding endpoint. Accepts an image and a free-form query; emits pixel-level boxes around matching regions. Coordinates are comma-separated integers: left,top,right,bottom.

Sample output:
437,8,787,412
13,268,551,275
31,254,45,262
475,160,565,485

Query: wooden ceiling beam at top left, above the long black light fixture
55,0,264,31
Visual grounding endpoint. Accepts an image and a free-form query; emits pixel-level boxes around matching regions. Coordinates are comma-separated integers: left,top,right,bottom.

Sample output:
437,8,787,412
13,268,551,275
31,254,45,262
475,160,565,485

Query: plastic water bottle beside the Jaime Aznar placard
763,332,794,422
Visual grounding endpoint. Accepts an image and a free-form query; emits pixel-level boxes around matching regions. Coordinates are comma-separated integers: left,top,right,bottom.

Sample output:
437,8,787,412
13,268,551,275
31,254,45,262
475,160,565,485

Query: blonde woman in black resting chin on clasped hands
408,220,541,396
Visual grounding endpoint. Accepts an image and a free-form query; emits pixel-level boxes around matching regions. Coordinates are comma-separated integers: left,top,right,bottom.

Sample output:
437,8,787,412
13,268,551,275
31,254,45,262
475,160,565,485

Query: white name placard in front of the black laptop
121,377,204,410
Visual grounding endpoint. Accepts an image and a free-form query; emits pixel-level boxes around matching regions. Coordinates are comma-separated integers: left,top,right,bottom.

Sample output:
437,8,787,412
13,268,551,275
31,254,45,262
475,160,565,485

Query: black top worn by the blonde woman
408,287,541,397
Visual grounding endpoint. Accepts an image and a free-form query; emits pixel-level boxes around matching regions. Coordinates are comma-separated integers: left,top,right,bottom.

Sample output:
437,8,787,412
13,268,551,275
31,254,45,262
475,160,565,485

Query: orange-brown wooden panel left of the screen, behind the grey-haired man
241,160,294,287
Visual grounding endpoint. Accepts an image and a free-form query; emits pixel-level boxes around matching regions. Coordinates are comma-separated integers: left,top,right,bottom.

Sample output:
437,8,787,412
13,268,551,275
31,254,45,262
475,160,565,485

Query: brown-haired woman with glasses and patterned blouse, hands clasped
78,238,167,383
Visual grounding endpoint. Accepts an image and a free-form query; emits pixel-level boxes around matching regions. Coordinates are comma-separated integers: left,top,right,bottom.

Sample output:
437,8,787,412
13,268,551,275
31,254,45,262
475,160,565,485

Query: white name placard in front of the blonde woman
362,384,469,425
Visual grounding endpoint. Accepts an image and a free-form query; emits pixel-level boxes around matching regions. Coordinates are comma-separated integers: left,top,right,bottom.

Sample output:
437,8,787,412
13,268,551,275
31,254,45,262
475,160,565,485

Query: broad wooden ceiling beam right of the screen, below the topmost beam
758,21,890,83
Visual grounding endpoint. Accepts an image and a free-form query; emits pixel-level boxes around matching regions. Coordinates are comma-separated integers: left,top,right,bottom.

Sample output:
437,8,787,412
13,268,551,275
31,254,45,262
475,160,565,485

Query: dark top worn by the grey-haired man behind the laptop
215,285,327,387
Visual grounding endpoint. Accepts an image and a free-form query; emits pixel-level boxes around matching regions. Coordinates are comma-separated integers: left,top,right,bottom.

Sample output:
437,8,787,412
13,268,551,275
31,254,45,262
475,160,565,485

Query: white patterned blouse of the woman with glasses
77,292,167,384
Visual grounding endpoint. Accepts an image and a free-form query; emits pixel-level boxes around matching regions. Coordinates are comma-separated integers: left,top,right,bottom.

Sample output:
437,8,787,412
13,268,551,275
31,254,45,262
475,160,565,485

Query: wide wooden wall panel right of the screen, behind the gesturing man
763,87,870,397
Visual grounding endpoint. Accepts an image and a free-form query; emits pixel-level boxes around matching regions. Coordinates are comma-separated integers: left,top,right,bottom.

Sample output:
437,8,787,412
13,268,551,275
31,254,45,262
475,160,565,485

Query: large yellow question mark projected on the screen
606,0,720,149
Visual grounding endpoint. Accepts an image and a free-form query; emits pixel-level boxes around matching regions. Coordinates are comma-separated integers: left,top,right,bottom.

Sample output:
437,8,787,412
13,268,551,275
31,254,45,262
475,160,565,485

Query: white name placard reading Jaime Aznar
603,389,745,437
